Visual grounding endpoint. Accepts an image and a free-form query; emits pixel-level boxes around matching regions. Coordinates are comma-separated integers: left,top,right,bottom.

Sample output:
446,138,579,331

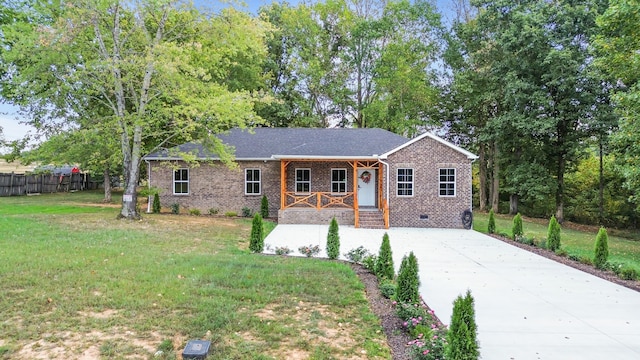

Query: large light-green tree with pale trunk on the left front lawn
2,0,268,219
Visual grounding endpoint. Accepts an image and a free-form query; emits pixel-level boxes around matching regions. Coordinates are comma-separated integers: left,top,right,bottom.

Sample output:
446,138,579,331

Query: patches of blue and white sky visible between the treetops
0,0,453,145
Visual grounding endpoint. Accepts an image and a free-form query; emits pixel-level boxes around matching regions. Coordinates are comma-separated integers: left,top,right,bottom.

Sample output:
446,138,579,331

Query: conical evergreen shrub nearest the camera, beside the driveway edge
446,290,480,360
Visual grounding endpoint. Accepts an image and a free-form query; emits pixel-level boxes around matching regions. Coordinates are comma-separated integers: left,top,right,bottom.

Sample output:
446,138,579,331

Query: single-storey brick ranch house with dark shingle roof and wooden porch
145,128,477,228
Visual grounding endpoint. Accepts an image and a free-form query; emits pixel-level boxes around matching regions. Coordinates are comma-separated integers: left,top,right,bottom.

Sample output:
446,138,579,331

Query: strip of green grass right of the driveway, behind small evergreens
473,212,640,271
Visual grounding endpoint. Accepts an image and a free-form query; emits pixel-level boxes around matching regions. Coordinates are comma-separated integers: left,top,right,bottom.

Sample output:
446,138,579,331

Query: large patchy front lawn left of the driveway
0,192,390,359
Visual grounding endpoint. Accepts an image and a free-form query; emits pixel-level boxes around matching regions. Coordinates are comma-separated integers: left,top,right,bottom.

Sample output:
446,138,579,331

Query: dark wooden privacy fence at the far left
0,173,98,196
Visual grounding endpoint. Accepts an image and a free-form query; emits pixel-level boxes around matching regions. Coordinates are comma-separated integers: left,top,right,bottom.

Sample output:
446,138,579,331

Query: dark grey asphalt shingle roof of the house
145,128,409,160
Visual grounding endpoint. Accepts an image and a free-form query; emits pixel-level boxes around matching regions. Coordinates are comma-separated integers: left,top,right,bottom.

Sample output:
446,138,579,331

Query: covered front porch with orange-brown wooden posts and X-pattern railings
278,158,389,229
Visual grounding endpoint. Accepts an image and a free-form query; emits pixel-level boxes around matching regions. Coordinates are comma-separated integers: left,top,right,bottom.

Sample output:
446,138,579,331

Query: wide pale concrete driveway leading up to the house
265,225,640,360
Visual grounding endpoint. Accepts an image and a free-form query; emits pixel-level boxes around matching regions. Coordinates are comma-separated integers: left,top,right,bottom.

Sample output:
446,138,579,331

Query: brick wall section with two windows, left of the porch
150,161,280,217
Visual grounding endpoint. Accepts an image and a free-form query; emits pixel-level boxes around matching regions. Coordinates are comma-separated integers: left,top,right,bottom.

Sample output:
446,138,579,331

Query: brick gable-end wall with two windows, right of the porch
387,137,471,228
